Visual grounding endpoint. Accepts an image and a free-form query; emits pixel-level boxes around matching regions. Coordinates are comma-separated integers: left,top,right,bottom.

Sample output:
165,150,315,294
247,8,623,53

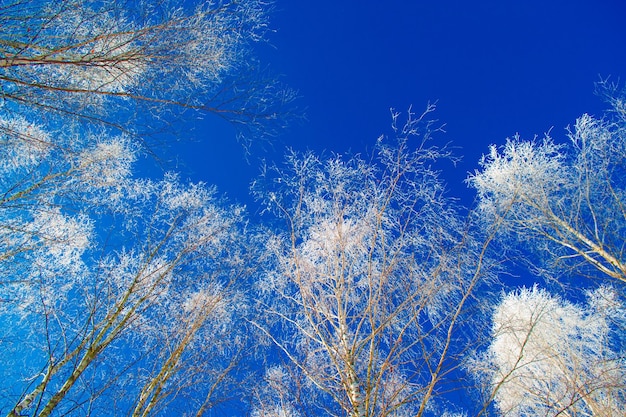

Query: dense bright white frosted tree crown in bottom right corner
474,287,626,416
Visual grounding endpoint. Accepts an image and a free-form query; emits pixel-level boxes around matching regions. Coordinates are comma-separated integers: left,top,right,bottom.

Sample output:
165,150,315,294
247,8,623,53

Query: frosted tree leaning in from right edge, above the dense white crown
468,83,626,283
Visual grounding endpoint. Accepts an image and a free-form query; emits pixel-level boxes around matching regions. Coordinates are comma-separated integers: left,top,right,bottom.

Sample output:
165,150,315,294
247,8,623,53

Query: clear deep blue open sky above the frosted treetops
177,0,626,205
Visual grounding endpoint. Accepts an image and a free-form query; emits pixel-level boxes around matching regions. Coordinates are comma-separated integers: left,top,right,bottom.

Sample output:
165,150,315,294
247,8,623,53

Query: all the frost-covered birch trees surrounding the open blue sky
0,0,626,417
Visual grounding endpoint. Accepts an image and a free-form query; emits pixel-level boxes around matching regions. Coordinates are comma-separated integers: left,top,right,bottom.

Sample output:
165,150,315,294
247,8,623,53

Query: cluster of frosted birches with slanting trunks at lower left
0,118,245,416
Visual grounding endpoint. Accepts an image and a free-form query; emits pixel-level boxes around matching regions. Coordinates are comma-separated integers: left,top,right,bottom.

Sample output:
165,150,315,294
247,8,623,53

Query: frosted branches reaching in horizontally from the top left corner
0,0,258,100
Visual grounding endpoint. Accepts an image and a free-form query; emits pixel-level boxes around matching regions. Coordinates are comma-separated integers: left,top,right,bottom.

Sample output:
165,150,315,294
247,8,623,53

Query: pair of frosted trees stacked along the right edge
469,79,626,416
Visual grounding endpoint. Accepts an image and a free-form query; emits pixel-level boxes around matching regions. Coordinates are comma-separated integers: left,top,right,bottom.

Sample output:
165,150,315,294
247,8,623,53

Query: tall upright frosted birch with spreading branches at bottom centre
254,106,492,417
